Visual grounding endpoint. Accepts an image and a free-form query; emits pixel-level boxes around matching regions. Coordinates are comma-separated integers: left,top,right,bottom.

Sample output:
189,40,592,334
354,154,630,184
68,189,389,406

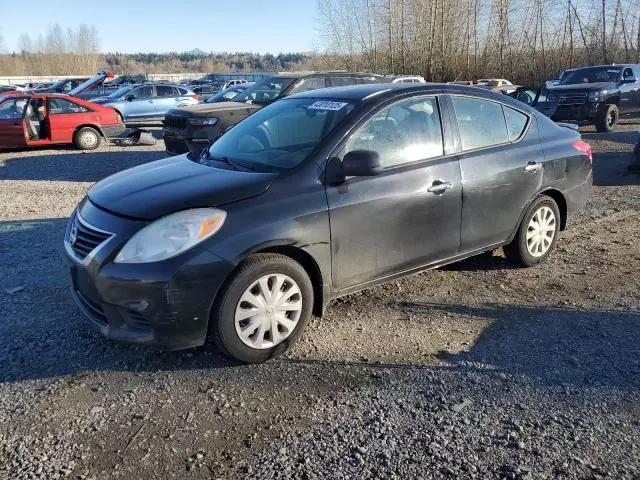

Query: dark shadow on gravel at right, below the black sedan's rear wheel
398,302,640,390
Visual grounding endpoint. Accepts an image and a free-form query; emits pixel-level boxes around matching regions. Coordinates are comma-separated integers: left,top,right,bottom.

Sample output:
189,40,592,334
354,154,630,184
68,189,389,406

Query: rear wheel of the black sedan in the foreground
503,195,561,267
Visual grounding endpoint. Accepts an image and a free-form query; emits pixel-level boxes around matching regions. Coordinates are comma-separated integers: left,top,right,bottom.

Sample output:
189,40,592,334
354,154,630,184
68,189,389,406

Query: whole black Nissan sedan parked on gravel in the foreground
64,84,592,362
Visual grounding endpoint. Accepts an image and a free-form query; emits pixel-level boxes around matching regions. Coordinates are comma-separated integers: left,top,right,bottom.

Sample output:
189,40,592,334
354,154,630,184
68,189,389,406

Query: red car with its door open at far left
0,93,125,150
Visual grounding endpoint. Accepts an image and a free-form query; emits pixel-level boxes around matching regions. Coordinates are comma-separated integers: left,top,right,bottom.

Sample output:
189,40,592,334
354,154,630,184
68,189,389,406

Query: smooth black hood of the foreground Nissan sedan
87,155,277,220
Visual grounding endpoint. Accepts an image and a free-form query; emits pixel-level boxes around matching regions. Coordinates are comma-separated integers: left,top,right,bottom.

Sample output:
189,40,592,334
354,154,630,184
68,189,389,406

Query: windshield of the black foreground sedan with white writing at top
201,98,355,172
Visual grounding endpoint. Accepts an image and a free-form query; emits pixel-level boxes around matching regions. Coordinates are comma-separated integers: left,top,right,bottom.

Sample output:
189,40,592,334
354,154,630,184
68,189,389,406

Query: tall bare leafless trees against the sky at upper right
318,0,640,83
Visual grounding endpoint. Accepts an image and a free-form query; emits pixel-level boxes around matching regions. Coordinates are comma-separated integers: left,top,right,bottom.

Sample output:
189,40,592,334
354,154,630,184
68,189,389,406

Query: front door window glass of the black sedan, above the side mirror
345,97,444,168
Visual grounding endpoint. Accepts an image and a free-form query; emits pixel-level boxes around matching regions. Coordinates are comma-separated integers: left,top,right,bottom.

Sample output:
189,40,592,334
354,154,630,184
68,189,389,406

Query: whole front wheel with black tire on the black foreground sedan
209,253,313,363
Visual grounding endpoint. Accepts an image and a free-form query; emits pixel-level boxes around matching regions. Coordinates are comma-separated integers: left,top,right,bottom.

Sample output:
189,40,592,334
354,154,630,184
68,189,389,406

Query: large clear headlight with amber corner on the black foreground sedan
114,208,227,263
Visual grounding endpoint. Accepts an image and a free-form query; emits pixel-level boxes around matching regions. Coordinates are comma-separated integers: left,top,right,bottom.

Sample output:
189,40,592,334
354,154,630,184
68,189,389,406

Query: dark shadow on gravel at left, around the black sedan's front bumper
0,218,237,383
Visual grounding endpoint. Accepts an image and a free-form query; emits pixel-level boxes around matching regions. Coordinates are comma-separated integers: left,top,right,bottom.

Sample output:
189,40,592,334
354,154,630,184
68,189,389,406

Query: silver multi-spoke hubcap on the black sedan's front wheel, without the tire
235,273,302,349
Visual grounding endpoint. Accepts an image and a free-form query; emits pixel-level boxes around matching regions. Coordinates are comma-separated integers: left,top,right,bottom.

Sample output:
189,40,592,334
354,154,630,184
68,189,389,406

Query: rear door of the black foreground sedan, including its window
449,95,545,252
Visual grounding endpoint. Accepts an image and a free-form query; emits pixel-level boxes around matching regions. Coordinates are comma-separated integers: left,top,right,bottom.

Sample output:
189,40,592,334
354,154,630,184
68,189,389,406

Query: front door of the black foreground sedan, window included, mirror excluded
326,96,462,290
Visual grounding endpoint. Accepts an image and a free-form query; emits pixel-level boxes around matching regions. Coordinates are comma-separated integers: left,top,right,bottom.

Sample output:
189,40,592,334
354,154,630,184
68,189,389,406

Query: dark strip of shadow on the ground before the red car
0,147,166,182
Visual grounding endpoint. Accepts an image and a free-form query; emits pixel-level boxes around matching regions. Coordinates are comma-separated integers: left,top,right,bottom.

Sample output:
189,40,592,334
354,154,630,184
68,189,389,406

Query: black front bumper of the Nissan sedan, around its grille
65,200,233,350
